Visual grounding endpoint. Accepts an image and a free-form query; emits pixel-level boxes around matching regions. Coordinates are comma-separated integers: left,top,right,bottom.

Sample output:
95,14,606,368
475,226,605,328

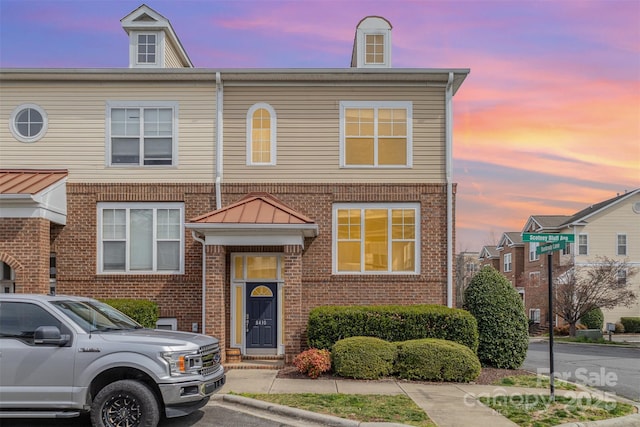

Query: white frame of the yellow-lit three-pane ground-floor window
331,202,422,276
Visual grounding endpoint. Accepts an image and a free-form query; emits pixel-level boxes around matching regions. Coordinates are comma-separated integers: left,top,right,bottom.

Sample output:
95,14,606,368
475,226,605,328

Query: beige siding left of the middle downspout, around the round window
0,81,215,183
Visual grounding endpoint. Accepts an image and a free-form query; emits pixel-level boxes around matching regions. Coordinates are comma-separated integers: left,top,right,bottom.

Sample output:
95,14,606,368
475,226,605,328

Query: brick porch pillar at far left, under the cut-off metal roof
0,218,51,294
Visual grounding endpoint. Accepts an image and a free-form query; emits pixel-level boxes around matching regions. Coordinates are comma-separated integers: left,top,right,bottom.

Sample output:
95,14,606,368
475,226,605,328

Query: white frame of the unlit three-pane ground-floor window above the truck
96,202,185,275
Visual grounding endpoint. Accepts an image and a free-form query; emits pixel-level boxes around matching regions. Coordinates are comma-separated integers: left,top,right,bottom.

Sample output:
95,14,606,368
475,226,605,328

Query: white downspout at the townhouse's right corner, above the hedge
445,71,454,308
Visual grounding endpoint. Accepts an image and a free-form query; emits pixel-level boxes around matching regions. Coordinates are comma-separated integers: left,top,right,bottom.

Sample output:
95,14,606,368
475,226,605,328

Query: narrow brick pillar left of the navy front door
205,245,228,362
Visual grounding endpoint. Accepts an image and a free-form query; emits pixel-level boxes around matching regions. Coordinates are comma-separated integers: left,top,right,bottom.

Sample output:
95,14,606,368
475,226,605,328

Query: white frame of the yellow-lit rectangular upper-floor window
340,101,413,169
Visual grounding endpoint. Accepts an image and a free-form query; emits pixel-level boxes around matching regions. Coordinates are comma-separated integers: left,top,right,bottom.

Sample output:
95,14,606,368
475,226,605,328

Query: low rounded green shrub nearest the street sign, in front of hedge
395,338,482,382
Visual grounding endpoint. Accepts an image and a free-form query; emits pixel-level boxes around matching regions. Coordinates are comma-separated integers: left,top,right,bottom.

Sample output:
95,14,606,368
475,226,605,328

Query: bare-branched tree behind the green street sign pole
553,257,638,337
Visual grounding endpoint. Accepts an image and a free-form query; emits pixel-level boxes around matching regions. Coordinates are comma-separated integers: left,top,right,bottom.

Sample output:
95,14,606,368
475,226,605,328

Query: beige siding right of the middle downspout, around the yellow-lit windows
224,85,445,183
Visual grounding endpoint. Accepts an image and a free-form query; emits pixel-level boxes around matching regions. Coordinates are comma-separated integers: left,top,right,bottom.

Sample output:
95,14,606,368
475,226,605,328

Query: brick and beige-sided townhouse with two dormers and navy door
0,5,469,361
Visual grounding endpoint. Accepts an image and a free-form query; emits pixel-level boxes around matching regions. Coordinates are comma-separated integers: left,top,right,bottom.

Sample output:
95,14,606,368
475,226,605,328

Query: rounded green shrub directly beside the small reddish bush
331,337,397,380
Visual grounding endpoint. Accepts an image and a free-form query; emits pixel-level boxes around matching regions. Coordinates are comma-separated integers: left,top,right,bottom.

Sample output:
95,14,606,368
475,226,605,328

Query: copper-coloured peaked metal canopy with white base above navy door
185,192,318,246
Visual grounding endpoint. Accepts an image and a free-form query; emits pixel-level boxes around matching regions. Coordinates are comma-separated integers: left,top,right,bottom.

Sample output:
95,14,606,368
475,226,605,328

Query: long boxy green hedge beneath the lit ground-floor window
307,304,478,352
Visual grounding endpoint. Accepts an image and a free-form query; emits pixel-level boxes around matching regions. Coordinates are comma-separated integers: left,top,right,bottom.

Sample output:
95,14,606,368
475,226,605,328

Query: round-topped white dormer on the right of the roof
351,16,392,68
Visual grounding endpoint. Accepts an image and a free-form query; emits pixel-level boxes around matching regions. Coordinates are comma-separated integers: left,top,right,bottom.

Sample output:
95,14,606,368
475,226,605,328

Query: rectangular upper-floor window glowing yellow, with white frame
340,101,413,168
